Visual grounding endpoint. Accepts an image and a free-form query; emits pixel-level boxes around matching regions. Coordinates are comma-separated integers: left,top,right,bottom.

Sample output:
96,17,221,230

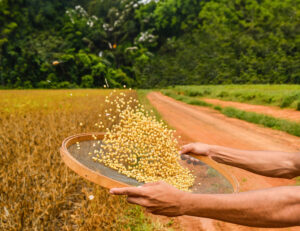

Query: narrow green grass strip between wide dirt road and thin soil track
162,90,300,137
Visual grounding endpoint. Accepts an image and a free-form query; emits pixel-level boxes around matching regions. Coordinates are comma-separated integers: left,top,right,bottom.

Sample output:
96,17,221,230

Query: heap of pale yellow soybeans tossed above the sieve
92,92,194,191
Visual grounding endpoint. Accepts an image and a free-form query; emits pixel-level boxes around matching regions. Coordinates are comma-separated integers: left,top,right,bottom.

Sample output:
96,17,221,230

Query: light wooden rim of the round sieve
60,132,239,192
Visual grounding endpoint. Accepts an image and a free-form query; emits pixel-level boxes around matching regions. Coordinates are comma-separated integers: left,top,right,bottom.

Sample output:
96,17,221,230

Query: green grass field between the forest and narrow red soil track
171,85,300,110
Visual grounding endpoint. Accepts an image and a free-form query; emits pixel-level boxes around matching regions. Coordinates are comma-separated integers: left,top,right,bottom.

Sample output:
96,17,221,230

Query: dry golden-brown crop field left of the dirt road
0,90,172,230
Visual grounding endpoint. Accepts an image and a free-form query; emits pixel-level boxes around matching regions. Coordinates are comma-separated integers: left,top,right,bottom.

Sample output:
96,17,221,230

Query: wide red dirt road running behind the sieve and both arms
147,92,300,231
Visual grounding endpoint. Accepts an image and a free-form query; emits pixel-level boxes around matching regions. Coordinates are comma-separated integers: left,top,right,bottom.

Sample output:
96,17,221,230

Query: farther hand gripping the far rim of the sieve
180,142,211,164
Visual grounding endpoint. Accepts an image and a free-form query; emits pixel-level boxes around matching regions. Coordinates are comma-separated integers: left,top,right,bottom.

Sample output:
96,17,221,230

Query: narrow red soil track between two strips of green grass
201,99,300,122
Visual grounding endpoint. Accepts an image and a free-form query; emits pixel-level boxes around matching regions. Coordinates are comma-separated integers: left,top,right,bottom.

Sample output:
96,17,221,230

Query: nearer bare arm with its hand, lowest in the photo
110,182,300,227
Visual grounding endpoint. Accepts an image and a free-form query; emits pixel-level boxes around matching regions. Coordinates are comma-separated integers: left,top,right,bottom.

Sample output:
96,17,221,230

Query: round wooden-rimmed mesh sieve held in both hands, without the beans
60,133,239,193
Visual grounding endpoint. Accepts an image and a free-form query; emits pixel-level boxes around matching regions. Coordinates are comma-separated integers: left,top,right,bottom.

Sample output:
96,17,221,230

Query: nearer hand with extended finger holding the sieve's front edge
110,182,188,217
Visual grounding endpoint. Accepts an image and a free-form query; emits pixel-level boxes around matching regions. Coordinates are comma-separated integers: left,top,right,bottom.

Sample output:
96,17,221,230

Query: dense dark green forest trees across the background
0,0,300,88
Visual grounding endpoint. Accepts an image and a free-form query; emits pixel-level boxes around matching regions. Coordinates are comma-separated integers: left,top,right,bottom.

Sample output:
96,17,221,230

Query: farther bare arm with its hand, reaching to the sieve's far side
181,143,300,178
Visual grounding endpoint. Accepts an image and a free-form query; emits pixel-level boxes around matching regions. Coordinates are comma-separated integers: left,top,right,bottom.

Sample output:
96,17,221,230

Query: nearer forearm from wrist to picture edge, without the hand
182,186,300,227
